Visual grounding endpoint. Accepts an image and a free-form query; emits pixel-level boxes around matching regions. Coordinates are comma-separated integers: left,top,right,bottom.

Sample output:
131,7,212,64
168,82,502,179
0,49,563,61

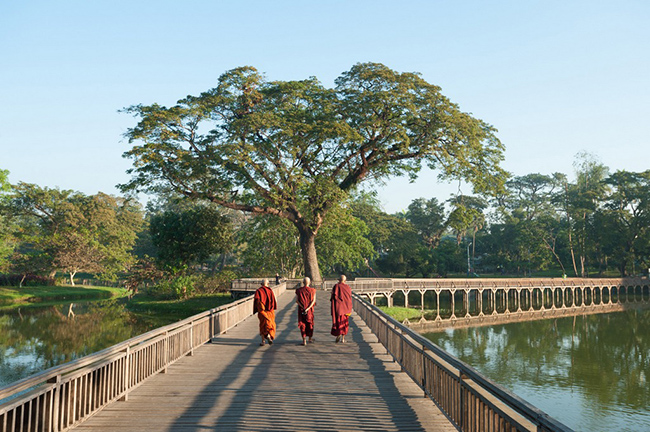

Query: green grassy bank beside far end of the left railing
127,293,233,319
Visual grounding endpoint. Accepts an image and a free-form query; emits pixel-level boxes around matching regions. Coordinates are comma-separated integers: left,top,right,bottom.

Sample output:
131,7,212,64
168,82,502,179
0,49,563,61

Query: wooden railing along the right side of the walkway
352,293,571,432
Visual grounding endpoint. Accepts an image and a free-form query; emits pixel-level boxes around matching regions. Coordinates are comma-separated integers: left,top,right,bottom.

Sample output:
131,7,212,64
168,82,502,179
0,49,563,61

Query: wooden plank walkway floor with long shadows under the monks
75,291,456,432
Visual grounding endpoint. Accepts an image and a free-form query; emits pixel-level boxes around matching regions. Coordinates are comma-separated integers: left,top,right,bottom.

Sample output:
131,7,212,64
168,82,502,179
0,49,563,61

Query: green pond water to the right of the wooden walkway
425,310,650,431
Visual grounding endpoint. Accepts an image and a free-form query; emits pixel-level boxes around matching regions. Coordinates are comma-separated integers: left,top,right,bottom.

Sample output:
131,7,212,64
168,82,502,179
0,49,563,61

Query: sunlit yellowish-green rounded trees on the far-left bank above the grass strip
8,183,142,284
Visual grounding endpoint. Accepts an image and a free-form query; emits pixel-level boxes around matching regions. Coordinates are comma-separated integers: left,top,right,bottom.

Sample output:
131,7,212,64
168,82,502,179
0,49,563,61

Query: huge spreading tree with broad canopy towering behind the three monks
123,63,505,281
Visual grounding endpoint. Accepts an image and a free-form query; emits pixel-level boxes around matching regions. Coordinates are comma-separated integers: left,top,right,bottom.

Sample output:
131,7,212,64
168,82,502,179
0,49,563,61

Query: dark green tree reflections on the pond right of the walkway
426,310,650,410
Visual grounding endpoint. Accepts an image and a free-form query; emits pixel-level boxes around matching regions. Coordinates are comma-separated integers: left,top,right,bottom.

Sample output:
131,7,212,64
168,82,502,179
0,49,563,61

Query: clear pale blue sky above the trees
0,0,650,212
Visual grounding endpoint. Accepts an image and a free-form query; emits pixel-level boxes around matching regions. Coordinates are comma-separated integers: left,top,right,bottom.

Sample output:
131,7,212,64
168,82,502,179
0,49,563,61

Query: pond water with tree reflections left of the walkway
0,300,170,386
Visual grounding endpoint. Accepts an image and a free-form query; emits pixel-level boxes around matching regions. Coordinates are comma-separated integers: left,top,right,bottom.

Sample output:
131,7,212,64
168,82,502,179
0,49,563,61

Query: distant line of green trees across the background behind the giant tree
0,149,650,296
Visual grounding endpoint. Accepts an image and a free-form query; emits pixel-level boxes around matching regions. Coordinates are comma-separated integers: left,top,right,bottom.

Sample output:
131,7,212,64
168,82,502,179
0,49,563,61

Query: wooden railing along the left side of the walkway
0,284,286,432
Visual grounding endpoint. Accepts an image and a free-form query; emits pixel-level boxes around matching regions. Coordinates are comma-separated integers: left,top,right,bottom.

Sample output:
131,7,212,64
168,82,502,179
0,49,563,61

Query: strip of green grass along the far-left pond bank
0,285,128,309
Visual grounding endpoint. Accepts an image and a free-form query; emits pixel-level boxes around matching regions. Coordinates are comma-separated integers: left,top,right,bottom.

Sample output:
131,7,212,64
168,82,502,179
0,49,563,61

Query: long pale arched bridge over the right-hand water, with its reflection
342,277,650,332
